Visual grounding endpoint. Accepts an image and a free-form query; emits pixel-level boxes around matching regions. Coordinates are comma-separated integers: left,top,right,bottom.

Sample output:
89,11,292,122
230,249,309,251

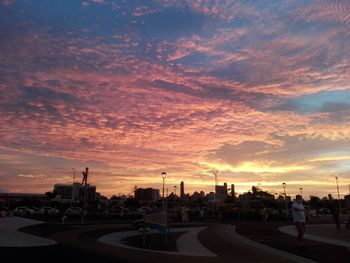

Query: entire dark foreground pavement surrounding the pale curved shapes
0,219,350,263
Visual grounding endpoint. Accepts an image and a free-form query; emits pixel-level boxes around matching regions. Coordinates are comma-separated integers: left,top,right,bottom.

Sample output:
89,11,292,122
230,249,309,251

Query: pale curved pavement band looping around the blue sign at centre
98,227,217,257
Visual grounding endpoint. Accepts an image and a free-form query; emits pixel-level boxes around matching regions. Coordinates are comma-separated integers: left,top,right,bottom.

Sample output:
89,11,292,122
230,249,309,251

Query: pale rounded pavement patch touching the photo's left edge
0,217,57,247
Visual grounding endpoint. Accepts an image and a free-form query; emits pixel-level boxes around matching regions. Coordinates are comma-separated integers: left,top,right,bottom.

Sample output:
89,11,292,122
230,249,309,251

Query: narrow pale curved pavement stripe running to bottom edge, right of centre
232,226,317,263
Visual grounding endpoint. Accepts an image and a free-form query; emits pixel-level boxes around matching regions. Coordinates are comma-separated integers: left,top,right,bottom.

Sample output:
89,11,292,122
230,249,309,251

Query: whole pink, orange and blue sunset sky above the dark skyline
0,0,350,198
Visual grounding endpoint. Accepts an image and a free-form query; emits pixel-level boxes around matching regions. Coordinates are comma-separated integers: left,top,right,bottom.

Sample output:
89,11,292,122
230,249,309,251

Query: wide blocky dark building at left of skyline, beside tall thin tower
54,183,96,201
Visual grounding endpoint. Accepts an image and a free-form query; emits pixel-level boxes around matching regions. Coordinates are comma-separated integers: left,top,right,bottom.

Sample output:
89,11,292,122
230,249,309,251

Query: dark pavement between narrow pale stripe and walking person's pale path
236,222,350,263
